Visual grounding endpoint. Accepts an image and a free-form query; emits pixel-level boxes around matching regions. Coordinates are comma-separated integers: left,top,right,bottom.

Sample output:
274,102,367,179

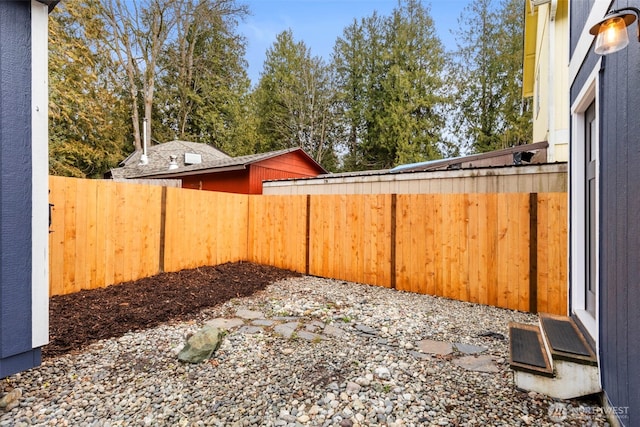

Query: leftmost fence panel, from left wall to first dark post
49,177,161,295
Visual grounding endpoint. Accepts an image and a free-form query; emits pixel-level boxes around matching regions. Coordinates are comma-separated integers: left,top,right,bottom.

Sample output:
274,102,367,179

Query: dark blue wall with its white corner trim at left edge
0,2,48,377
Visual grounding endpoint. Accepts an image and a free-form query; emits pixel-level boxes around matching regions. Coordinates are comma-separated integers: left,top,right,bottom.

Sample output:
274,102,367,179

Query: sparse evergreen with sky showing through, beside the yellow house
452,0,531,152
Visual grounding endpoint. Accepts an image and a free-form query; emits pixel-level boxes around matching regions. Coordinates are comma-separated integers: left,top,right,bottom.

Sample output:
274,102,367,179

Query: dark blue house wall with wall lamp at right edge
570,0,640,426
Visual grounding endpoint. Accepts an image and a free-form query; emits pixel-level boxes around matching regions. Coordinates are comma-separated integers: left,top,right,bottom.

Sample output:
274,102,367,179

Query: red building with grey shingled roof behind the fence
108,141,327,194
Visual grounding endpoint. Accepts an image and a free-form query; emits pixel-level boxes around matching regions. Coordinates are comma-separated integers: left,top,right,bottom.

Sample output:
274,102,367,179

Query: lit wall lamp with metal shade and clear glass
589,7,640,55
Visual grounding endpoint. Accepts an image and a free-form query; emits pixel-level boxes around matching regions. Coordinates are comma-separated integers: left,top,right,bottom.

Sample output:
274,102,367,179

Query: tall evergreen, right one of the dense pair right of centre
379,0,444,167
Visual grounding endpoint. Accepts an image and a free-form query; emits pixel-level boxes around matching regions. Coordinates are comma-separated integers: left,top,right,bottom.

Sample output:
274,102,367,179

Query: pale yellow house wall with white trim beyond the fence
525,0,569,162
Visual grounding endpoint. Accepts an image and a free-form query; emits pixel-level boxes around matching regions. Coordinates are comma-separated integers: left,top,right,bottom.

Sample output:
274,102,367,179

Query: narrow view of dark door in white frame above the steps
584,102,598,318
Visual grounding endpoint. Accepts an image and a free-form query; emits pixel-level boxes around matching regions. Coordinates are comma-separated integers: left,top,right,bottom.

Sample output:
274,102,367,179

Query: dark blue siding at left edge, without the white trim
0,2,40,378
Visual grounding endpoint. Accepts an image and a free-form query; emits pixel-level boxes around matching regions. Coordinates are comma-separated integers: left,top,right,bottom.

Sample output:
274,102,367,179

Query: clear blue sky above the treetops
239,0,470,84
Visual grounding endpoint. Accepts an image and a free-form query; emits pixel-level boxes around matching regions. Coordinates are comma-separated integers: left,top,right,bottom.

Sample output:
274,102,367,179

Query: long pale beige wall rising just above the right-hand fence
263,163,567,194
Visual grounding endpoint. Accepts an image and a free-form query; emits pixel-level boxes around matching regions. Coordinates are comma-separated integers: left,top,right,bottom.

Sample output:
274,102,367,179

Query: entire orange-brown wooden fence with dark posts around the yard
50,177,568,314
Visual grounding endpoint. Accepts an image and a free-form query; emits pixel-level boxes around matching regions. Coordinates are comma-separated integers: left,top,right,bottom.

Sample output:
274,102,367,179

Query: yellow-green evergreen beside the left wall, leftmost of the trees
49,0,130,178
